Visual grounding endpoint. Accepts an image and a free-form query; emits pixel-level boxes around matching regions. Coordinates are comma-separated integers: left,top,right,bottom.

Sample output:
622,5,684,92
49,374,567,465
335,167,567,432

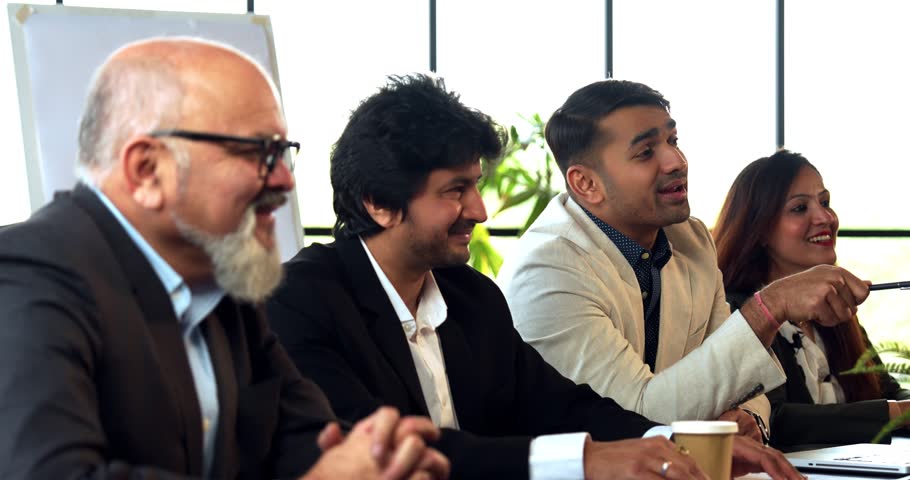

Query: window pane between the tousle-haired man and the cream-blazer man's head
437,0,605,227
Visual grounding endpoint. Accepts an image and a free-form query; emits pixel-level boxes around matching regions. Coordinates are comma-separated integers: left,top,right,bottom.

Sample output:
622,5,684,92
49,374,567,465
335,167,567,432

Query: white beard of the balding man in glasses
174,205,283,303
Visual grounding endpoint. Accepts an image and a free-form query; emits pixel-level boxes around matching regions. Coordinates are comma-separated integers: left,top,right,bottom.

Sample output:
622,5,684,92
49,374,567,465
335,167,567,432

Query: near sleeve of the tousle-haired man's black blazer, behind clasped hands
267,264,531,479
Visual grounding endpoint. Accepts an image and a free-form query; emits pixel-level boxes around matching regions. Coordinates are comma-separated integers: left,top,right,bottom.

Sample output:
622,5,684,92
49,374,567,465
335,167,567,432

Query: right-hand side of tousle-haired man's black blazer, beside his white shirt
433,266,657,472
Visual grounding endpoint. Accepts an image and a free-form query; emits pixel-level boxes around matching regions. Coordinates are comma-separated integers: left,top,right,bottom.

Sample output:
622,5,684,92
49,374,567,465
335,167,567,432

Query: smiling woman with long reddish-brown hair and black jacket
714,150,910,448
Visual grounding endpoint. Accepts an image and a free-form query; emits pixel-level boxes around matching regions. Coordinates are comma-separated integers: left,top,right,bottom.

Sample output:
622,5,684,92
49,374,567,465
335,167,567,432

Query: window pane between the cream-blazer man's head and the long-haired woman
613,0,775,227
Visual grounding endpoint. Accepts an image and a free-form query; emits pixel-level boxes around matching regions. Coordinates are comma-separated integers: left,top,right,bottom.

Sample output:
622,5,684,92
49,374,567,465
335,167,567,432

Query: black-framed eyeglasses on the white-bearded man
149,129,300,179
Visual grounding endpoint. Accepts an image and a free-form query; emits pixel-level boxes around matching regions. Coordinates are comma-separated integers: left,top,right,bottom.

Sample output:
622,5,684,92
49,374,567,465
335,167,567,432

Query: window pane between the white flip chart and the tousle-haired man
256,0,429,229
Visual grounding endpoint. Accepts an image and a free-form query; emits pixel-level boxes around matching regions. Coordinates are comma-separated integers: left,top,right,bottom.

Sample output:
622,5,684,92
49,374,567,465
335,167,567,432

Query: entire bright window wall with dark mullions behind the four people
0,0,910,348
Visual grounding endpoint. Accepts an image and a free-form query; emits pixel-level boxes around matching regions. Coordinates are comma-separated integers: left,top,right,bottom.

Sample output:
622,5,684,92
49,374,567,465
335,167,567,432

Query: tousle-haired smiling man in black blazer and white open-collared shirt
268,76,812,478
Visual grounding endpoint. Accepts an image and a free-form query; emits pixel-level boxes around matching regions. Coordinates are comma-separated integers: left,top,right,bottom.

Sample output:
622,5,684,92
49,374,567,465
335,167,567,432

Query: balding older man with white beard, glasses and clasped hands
0,39,448,480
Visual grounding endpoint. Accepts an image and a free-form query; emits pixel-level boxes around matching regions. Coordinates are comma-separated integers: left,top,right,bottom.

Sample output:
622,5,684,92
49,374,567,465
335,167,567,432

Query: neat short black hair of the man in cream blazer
545,79,670,175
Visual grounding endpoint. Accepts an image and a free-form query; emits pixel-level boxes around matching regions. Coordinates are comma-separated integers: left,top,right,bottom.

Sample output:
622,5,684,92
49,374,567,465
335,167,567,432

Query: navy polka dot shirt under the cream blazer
582,207,673,372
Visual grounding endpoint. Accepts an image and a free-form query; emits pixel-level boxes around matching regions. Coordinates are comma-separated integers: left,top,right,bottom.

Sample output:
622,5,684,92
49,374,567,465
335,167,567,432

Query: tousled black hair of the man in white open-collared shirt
331,74,507,238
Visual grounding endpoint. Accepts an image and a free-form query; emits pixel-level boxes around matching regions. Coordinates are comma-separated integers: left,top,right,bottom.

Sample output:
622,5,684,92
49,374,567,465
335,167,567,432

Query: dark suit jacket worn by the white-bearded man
0,186,333,480
